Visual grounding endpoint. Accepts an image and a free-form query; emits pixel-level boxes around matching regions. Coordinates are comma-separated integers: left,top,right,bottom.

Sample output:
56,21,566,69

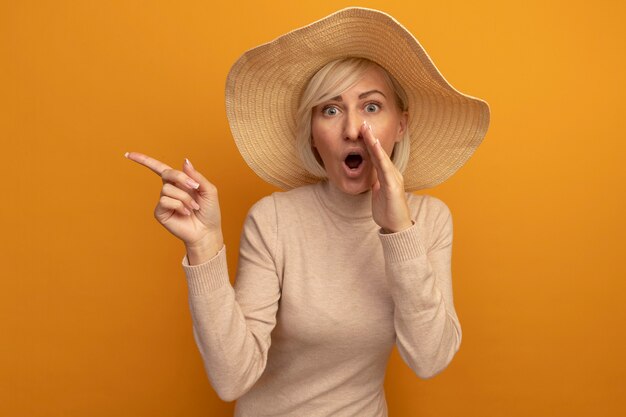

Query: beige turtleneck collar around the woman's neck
315,180,372,220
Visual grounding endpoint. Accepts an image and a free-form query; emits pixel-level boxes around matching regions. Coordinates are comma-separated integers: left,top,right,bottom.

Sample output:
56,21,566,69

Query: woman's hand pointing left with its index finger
125,152,224,265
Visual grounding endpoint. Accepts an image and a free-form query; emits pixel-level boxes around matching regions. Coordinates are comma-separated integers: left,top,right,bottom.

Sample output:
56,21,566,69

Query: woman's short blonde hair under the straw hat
296,58,411,178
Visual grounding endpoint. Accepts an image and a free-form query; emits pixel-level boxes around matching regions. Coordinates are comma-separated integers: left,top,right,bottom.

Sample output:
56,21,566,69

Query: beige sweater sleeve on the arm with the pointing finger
183,197,280,401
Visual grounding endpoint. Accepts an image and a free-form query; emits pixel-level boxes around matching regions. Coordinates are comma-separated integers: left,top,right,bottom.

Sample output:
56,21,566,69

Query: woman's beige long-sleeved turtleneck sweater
183,182,461,417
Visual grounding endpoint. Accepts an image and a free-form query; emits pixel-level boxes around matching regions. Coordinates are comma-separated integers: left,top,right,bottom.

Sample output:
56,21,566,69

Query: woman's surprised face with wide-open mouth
311,67,407,194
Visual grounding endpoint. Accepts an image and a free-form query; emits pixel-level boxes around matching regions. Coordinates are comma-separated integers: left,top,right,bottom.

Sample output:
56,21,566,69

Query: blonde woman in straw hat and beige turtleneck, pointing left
127,8,489,416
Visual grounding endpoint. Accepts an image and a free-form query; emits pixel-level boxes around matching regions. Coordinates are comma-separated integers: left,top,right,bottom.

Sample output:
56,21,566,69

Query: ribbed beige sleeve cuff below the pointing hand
182,246,230,295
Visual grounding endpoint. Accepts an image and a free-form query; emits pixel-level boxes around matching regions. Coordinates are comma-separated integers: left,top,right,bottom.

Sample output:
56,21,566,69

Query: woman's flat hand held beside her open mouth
361,123,413,233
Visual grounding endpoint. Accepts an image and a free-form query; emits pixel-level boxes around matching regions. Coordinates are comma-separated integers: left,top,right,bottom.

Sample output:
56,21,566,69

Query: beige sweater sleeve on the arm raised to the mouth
380,197,461,378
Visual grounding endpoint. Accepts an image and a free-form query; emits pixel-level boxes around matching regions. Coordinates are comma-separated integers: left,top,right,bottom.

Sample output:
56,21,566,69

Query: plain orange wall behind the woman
0,0,626,417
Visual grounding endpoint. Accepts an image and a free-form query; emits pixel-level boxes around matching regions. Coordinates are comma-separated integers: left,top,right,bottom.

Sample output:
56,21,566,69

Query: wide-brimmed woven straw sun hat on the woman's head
226,7,489,191
